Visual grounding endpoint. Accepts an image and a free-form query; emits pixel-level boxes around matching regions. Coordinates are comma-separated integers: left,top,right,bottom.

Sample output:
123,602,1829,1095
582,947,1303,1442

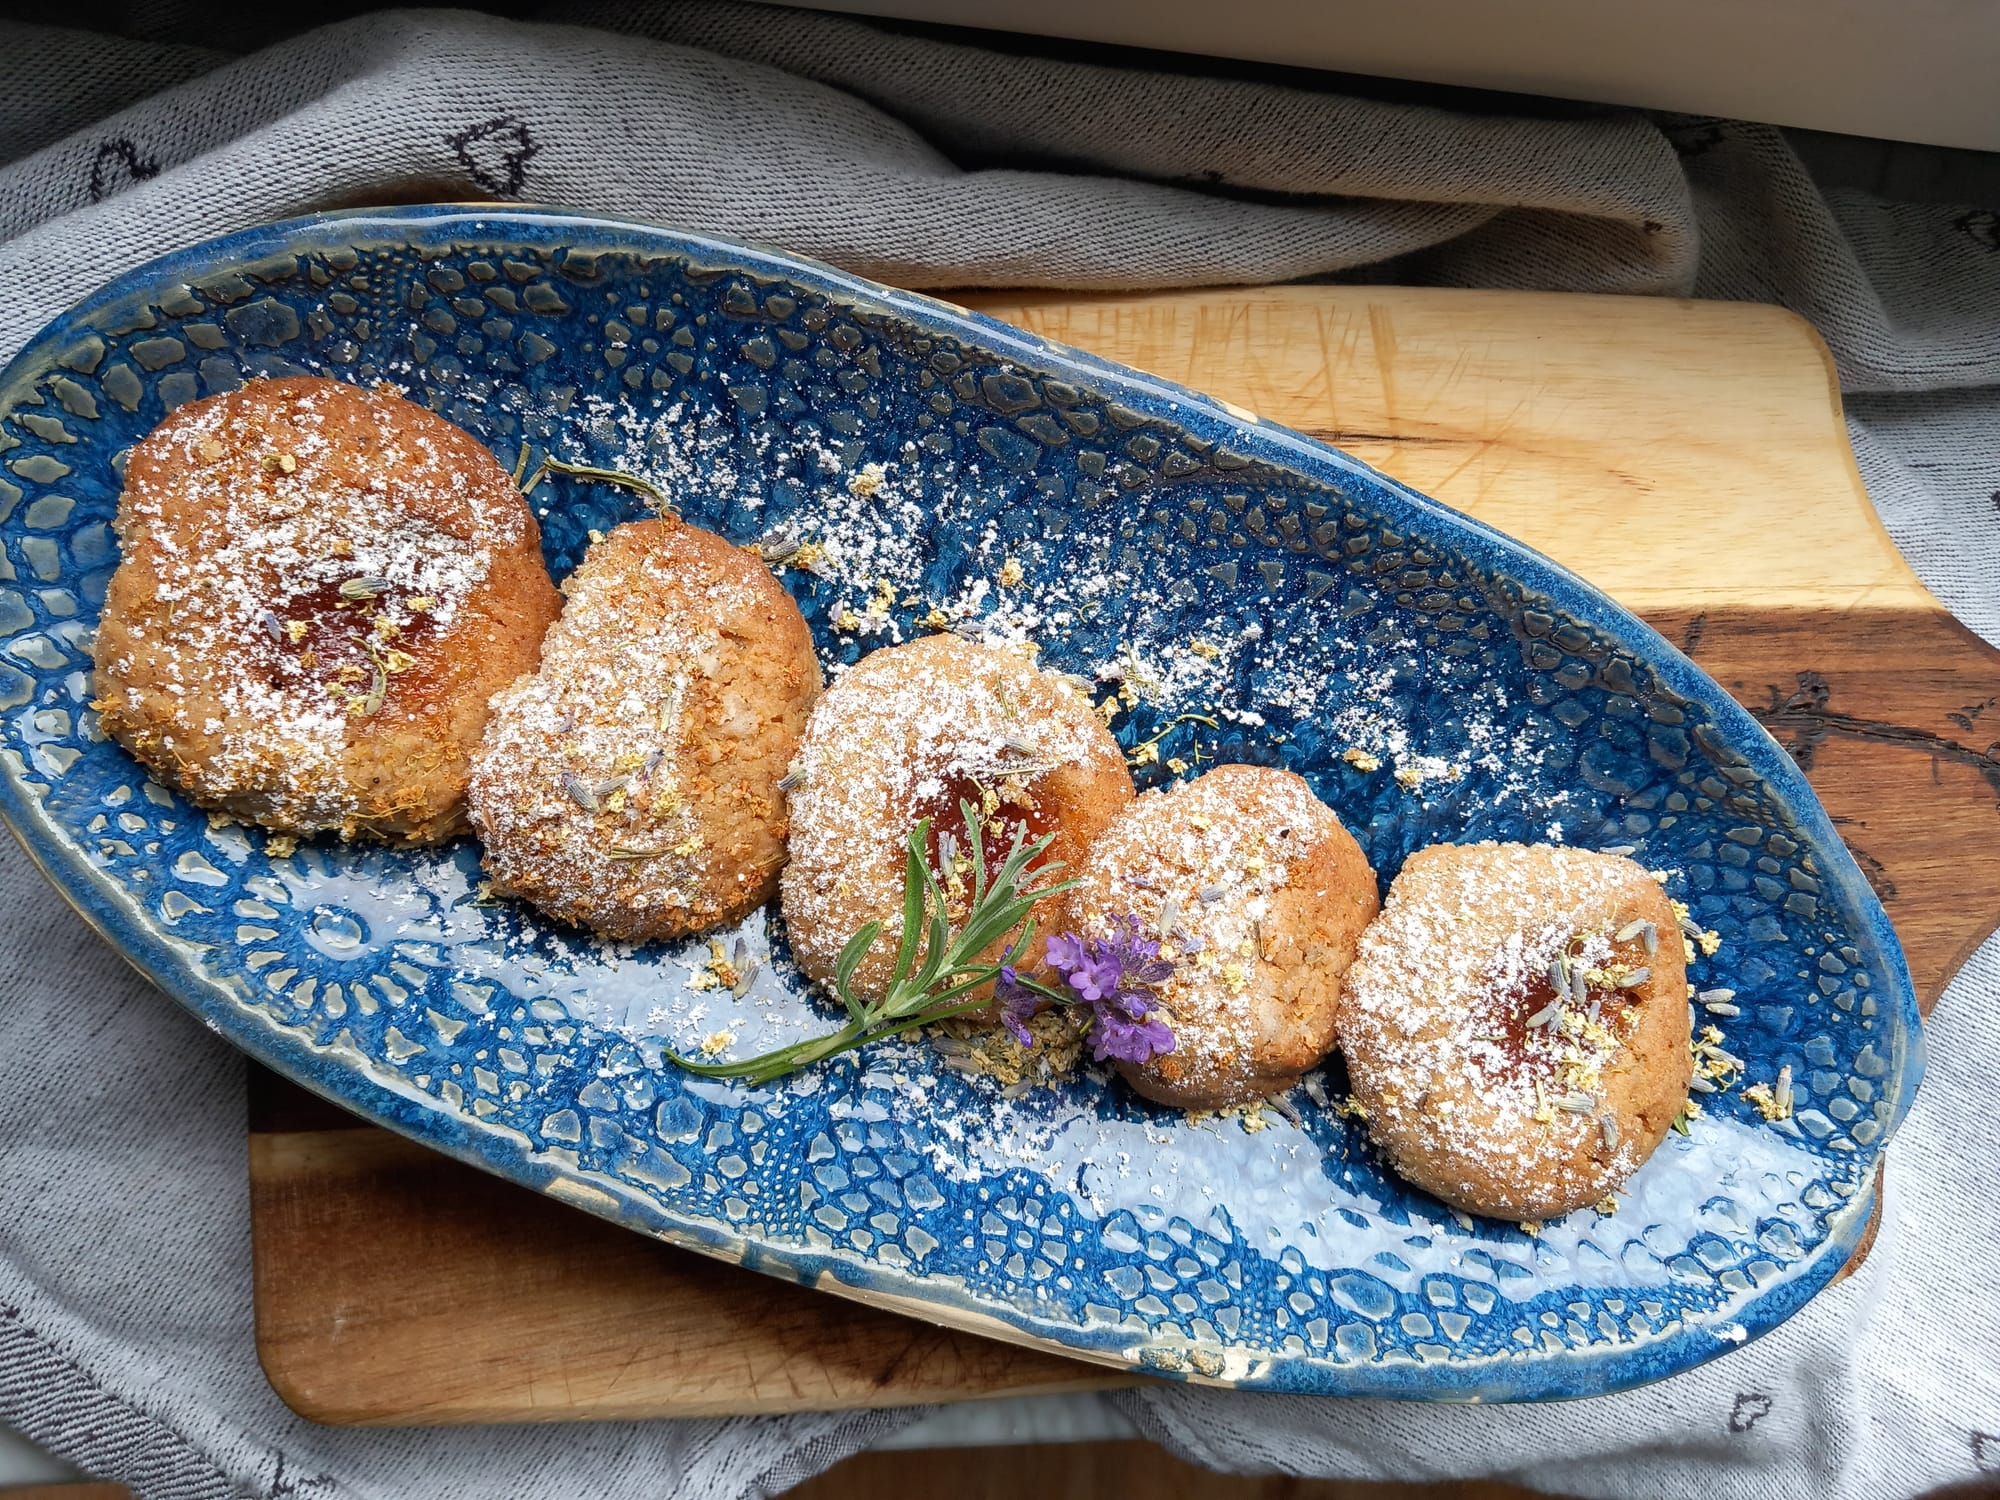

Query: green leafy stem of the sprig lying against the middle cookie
666,802,1076,1084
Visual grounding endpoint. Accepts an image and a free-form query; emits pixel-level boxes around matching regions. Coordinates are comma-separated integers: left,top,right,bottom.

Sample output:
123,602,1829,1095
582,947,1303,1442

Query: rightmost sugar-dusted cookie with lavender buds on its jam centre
1340,844,1692,1220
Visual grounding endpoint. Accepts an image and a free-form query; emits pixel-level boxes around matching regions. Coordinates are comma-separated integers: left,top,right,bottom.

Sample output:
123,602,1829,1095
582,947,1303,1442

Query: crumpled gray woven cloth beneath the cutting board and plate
0,4,2000,1500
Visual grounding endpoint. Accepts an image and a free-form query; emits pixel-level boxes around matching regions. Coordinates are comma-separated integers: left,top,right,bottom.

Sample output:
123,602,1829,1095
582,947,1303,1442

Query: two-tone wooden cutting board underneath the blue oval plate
250,286,2000,1424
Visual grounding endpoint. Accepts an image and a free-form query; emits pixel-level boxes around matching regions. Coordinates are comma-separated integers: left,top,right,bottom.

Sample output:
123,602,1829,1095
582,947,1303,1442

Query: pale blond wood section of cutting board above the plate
974,286,1936,614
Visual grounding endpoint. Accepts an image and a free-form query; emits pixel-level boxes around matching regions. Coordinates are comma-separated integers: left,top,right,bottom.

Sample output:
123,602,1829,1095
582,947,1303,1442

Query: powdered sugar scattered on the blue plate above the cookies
538,396,1574,848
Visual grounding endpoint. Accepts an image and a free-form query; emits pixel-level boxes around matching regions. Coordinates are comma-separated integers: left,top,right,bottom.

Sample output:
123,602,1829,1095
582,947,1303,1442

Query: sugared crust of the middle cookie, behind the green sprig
782,634,1132,1012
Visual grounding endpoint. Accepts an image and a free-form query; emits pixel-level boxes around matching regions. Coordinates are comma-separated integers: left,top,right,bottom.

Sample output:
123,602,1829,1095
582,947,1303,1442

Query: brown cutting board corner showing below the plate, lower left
250,1128,1128,1426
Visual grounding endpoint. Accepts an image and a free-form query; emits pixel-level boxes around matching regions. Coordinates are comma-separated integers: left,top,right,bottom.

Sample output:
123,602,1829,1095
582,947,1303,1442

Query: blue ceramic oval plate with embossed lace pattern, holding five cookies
0,208,1920,1400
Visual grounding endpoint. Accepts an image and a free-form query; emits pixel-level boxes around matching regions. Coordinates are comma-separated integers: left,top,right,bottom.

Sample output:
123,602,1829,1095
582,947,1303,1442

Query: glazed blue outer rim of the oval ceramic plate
0,204,1924,1402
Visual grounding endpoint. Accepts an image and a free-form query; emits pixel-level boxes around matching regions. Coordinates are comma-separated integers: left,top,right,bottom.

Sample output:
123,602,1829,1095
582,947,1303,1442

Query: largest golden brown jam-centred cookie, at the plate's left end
94,376,558,844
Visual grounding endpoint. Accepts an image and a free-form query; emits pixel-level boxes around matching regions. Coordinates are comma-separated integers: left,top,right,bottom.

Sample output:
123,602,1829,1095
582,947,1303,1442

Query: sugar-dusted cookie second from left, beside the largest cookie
472,518,820,942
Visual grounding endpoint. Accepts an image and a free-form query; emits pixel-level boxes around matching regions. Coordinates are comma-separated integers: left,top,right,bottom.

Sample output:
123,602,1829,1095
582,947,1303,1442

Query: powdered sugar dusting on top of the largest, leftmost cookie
100,382,528,830
